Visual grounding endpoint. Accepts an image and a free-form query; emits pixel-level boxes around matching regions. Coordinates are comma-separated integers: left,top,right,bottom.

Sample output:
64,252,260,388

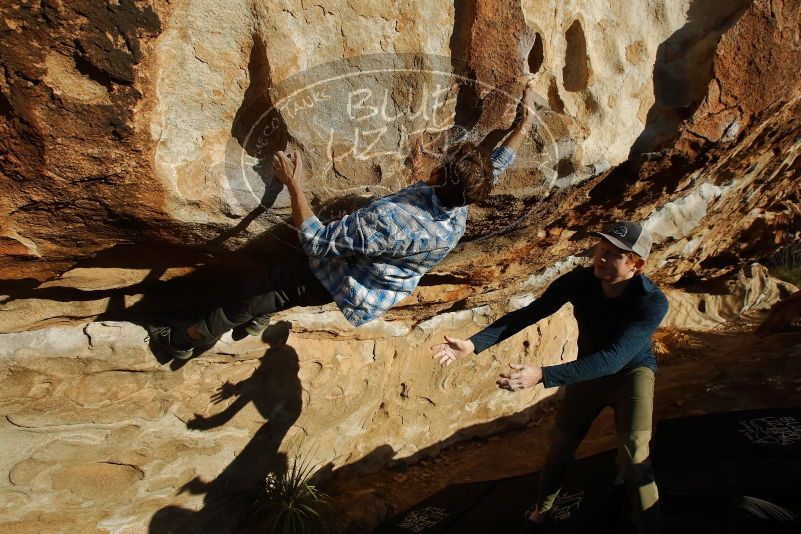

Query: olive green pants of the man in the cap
537,367,659,533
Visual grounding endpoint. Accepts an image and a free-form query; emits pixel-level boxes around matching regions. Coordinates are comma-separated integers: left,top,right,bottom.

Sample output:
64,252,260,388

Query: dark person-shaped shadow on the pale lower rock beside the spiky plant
149,326,303,534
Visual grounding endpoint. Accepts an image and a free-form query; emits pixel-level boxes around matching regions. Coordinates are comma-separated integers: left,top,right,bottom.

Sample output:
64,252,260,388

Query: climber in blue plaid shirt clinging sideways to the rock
150,87,534,360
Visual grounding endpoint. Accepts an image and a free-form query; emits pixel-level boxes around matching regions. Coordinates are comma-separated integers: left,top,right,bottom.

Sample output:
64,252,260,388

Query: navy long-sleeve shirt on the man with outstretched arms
470,267,668,387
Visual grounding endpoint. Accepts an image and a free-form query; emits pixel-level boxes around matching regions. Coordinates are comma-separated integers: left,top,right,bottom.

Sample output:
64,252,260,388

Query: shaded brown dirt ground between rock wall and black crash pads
326,318,801,532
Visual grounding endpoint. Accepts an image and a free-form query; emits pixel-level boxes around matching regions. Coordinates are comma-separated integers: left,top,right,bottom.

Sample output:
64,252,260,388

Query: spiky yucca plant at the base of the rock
247,457,334,534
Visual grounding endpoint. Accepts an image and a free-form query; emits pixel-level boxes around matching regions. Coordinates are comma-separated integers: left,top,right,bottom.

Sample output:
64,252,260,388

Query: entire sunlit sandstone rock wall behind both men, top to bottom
0,0,801,532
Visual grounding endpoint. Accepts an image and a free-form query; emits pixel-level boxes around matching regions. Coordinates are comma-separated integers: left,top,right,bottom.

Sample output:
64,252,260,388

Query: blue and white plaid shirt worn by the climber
299,146,515,326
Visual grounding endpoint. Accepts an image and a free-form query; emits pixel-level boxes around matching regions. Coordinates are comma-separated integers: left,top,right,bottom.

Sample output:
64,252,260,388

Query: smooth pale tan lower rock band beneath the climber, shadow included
0,309,575,532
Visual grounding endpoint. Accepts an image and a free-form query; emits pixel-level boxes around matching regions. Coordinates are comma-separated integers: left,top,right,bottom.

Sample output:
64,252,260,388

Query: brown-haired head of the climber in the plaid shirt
429,143,492,208
